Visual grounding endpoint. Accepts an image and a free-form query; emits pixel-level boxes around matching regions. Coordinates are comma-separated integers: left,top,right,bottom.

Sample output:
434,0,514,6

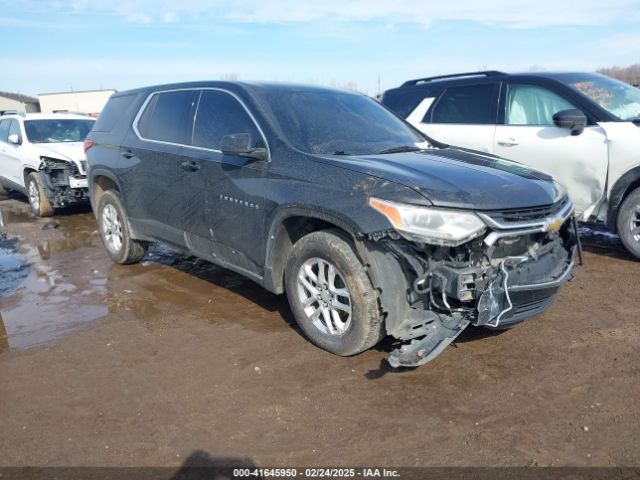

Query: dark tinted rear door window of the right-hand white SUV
425,83,498,124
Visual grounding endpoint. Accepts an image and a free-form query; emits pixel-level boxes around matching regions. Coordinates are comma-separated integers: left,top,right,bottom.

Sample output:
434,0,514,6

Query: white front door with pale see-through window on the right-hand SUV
494,81,608,214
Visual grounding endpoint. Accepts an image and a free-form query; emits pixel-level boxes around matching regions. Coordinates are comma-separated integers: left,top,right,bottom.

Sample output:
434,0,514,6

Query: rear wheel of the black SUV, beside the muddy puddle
96,190,149,265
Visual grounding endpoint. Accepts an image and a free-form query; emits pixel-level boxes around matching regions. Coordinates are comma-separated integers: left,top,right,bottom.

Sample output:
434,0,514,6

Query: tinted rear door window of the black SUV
138,90,196,144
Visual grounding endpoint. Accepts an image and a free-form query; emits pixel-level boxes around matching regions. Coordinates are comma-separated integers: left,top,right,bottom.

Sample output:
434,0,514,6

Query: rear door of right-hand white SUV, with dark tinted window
407,82,500,153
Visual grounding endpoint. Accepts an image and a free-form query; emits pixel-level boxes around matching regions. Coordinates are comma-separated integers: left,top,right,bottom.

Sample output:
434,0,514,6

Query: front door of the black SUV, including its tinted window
182,89,268,274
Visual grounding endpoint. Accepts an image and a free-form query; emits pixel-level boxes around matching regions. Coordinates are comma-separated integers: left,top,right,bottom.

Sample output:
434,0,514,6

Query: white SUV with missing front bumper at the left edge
0,112,95,217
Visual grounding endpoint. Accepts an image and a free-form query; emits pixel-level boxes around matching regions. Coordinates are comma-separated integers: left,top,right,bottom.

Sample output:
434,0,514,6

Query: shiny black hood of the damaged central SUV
321,148,562,210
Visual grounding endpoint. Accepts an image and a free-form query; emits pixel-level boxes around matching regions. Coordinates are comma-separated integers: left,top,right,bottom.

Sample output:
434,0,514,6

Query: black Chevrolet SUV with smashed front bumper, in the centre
85,82,576,366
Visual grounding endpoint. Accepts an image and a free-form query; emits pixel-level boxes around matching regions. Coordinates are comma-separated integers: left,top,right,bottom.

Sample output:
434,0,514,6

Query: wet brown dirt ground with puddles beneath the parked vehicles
0,191,640,466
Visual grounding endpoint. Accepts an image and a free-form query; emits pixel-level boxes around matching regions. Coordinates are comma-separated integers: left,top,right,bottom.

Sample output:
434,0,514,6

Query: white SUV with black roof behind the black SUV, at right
382,71,640,258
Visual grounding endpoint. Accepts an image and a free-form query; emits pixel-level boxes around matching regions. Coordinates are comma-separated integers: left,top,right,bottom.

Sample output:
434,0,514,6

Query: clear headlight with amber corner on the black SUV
369,197,487,247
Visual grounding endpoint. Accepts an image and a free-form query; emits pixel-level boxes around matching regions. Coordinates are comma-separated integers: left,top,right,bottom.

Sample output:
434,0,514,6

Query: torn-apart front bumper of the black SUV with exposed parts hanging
368,200,579,367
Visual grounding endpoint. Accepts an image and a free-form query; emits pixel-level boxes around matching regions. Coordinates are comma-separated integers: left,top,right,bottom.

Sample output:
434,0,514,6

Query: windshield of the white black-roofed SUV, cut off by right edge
564,75,640,120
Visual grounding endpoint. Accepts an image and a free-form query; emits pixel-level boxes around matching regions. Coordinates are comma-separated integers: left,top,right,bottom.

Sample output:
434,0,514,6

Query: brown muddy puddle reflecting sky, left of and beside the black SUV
0,199,290,351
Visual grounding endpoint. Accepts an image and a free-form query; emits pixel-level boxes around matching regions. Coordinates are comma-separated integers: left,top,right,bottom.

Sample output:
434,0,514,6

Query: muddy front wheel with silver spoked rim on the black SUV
285,230,383,356
